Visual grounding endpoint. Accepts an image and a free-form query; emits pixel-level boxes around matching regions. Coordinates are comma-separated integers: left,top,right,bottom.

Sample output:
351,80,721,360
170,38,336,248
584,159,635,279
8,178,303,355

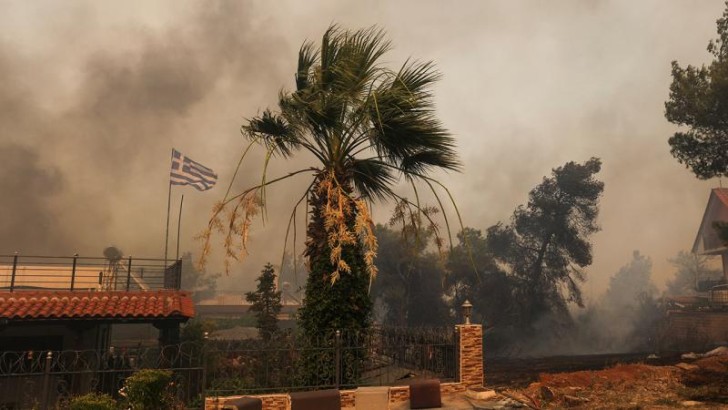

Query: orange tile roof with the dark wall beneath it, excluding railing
0,289,194,351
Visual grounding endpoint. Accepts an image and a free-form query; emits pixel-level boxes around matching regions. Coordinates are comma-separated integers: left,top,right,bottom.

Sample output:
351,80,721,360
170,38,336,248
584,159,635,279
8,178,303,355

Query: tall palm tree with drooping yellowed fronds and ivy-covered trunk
203,26,459,334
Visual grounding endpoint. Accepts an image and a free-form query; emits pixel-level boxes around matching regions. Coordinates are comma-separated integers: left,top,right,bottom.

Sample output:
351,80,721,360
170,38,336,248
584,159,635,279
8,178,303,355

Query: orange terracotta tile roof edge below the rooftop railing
0,290,195,320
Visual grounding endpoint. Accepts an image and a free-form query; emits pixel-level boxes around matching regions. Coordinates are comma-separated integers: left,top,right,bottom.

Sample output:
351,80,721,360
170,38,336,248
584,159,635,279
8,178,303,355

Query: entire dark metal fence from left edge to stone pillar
0,328,458,410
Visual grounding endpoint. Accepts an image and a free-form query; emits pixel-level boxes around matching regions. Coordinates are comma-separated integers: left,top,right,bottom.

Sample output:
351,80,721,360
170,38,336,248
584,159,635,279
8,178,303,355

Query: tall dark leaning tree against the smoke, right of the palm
486,158,604,325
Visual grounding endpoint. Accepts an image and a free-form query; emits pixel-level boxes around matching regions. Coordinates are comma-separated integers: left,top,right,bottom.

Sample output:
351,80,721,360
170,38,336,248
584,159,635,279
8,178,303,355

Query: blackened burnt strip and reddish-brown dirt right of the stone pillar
486,354,728,409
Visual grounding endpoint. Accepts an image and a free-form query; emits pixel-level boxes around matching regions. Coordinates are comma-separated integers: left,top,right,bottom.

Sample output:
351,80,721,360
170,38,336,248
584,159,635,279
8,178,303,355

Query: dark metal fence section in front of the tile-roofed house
0,343,204,410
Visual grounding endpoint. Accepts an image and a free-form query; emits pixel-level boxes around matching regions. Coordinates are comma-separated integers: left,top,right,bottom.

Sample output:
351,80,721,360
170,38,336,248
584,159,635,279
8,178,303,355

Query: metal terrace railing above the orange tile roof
0,254,182,292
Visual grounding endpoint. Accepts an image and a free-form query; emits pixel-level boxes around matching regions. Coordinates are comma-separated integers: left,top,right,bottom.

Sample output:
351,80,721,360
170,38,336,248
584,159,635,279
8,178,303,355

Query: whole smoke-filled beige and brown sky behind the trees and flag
0,0,723,295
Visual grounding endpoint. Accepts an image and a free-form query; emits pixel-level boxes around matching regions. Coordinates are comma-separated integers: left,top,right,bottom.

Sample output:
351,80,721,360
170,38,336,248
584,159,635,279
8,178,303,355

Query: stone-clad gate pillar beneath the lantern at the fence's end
456,325,485,387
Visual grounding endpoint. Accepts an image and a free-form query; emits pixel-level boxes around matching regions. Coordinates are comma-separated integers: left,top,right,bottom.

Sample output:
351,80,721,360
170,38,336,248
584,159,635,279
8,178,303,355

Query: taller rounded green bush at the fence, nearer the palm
121,369,175,410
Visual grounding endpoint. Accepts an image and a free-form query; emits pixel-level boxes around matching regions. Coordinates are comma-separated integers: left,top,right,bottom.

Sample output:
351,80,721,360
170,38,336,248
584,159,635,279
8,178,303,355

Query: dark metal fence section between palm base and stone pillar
207,328,457,396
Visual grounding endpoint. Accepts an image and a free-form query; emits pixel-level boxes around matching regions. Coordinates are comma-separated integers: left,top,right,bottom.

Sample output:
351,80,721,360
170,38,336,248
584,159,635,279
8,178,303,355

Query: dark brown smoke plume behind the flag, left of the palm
0,3,292,288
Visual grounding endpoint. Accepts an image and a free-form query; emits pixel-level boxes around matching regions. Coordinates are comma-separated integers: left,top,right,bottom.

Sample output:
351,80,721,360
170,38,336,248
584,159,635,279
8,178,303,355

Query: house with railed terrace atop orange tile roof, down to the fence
0,255,195,351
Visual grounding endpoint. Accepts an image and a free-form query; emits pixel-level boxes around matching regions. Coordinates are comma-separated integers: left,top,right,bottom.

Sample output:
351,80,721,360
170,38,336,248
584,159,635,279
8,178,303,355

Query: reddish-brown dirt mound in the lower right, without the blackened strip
499,355,728,409
